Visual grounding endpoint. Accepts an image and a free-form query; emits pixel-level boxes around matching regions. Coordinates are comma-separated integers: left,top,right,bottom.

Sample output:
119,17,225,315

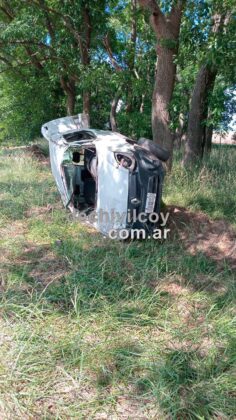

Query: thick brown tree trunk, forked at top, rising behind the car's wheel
139,0,185,170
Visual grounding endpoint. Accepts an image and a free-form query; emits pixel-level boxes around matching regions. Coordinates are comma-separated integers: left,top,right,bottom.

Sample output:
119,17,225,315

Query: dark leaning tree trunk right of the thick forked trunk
184,65,217,165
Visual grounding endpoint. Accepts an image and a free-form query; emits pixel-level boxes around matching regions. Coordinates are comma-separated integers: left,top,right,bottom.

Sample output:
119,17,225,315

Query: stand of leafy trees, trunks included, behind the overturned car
0,0,235,163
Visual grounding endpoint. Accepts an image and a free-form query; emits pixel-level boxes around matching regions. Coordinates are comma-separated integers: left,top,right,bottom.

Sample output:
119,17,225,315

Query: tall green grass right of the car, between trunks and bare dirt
164,145,236,224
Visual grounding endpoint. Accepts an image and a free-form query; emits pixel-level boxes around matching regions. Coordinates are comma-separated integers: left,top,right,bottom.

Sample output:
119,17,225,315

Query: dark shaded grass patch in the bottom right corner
136,345,234,419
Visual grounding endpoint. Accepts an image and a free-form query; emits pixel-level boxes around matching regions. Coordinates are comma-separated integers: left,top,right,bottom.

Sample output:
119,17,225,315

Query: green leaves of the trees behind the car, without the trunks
0,0,235,143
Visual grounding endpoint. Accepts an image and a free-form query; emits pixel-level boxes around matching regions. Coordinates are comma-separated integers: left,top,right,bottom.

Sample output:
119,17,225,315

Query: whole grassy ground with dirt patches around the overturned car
0,146,236,420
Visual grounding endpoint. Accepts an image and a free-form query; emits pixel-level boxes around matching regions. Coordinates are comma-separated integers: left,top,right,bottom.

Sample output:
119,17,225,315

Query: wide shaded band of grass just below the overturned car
1,221,235,316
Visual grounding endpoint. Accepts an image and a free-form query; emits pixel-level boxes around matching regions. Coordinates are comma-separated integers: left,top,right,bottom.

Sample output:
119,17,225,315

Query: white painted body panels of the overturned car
42,114,132,234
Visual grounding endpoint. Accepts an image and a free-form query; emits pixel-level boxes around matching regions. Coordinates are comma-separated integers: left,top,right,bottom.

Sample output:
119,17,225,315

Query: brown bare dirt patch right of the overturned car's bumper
168,206,236,269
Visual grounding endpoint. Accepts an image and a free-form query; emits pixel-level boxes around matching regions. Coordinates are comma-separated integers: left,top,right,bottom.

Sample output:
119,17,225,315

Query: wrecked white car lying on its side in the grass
42,114,169,235
